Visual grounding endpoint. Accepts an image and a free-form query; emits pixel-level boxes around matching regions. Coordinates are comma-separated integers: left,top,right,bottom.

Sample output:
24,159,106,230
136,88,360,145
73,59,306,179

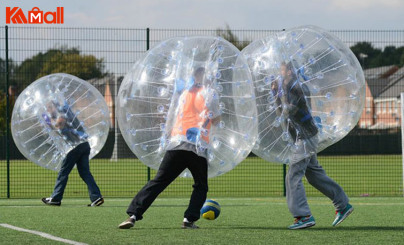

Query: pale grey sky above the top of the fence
0,0,404,30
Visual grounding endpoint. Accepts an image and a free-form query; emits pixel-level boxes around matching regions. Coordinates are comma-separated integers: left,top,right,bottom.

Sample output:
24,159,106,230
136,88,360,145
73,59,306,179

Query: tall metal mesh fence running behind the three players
0,27,404,198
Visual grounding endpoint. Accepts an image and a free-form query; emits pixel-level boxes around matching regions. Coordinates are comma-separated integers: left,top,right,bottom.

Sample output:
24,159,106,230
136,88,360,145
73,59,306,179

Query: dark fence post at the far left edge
4,26,10,198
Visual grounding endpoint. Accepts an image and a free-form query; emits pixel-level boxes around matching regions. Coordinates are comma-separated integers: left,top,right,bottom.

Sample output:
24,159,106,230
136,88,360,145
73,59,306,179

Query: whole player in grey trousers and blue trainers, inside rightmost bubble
272,62,353,229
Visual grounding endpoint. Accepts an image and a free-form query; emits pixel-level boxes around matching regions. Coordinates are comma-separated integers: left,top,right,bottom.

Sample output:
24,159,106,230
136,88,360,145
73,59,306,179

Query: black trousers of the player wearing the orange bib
126,150,208,222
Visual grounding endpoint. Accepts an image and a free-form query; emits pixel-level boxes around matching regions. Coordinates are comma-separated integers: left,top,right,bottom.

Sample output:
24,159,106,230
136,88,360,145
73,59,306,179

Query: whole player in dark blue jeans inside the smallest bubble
42,101,104,207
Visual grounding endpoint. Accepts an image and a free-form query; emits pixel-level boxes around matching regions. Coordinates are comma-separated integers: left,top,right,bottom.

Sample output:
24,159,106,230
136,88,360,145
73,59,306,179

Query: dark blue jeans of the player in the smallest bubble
51,142,101,202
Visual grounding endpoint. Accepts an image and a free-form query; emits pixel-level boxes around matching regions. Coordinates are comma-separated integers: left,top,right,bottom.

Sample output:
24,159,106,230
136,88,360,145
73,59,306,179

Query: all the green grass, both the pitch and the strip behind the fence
0,155,404,245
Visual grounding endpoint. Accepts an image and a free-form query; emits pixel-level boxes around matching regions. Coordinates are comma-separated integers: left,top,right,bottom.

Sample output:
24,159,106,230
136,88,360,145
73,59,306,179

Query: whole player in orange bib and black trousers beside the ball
119,67,220,229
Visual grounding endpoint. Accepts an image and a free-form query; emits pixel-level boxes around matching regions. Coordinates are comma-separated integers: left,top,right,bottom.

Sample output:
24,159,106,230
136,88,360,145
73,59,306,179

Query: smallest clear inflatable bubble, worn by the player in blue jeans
11,73,110,171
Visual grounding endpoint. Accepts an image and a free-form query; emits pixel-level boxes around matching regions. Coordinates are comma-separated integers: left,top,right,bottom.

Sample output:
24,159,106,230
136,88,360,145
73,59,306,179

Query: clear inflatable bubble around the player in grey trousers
242,26,365,164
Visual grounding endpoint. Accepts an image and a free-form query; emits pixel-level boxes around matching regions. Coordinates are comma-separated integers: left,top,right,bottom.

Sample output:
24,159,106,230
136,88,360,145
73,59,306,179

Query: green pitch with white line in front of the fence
0,197,404,245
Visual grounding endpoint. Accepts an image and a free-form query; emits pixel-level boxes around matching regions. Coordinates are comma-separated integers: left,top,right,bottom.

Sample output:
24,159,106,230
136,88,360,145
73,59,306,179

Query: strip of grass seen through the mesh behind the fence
0,155,403,198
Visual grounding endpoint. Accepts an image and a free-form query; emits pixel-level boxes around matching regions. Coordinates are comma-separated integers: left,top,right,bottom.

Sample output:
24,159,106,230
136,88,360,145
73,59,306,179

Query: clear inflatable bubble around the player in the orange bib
116,36,257,177
